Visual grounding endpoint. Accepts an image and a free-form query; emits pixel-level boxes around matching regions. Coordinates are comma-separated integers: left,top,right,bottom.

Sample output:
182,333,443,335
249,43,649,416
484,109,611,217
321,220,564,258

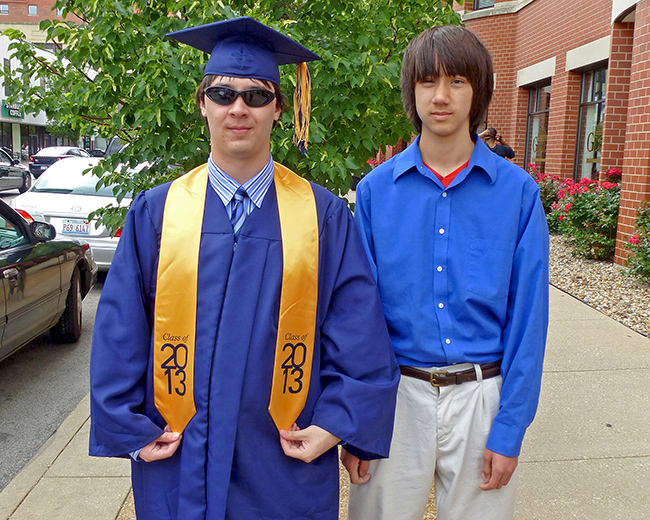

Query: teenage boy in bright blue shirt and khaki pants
342,26,548,520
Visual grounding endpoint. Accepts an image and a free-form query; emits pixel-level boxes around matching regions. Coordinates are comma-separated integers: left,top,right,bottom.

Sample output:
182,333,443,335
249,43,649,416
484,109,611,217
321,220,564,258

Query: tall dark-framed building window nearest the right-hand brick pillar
574,68,607,180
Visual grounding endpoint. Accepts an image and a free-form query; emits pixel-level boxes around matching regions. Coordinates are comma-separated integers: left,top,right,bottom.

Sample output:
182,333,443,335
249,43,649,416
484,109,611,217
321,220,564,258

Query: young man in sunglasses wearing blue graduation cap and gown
90,18,399,520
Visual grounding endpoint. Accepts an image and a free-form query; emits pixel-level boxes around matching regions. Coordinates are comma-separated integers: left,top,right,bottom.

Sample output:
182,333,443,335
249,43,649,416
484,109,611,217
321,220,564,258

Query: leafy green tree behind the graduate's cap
3,0,460,223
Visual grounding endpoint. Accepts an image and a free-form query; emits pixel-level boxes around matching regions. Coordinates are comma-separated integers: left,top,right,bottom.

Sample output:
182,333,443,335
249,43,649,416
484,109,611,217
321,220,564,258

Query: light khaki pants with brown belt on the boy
348,365,517,520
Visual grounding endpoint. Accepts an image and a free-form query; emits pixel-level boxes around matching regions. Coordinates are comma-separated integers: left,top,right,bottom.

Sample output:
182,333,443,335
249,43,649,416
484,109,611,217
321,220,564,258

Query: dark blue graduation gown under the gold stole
90,180,399,520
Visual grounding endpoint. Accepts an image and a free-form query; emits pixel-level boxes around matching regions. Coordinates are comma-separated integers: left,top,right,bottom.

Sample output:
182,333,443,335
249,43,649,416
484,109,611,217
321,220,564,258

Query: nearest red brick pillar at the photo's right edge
616,0,650,264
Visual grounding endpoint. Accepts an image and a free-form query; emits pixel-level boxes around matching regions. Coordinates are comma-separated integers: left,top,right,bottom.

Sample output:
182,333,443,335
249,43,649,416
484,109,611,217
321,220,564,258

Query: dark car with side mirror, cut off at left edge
0,200,97,360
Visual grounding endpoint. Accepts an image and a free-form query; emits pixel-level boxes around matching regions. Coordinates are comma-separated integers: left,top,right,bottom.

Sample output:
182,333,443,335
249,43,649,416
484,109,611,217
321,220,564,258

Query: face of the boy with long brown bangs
415,74,474,139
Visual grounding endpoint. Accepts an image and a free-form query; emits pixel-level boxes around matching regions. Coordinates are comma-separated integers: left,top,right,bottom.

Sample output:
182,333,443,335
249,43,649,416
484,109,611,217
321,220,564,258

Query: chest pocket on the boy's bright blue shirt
467,239,515,300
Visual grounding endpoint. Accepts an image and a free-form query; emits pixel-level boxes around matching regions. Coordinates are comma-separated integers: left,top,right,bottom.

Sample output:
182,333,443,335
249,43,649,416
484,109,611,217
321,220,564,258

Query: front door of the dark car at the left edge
0,206,63,357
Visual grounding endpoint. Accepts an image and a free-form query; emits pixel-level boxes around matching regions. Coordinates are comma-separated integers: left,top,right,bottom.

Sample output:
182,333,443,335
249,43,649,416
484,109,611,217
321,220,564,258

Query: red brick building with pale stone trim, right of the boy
456,0,650,263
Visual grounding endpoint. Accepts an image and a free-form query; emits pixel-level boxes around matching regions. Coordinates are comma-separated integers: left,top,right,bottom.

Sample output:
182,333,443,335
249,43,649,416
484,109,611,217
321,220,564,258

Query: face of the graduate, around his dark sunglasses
200,76,281,168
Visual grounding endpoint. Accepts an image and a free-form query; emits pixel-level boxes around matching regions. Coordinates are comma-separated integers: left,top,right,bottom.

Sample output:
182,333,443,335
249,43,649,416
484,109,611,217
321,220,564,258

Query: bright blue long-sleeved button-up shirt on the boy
355,138,548,456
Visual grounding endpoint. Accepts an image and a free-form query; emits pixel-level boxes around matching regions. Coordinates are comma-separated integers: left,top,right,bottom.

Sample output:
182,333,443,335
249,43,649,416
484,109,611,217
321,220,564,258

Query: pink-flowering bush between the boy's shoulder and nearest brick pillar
551,179,620,260
